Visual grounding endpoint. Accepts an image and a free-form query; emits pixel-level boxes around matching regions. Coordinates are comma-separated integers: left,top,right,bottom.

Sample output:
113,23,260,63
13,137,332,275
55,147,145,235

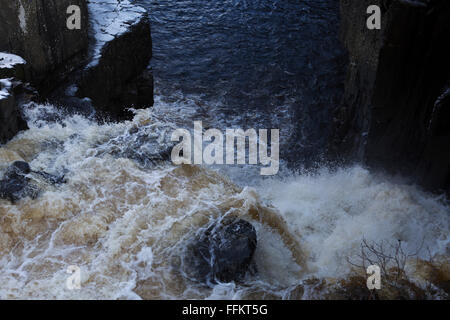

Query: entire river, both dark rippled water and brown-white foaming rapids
0,0,450,299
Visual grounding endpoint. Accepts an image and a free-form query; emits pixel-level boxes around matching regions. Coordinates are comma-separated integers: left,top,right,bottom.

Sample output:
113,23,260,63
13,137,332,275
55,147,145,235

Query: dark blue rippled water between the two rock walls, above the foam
136,0,344,168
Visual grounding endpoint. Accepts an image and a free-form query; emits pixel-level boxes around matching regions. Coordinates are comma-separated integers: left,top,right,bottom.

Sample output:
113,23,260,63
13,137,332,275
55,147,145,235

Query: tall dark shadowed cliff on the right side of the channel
331,0,450,191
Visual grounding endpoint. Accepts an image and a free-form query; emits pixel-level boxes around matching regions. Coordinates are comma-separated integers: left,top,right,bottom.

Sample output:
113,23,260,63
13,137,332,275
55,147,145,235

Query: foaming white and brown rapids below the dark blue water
0,102,449,299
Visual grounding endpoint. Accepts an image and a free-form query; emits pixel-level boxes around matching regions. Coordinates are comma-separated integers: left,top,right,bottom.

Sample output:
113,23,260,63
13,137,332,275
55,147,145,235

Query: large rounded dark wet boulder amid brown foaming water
185,219,257,283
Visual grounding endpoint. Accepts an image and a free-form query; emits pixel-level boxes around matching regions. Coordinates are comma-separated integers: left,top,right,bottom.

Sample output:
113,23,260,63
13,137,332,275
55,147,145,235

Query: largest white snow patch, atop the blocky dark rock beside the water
87,0,146,68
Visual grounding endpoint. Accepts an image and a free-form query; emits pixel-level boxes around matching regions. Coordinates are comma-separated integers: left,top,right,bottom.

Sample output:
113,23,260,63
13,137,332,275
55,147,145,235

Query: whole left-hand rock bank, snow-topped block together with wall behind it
0,0,153,143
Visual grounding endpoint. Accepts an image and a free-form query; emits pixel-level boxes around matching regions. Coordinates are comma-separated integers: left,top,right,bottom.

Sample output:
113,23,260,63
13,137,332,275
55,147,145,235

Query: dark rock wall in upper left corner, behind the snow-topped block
0,0,89,143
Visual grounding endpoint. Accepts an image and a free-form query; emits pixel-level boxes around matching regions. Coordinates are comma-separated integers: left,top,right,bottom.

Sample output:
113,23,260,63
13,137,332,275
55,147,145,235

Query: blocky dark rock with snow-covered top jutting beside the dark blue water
77,0,153,118
